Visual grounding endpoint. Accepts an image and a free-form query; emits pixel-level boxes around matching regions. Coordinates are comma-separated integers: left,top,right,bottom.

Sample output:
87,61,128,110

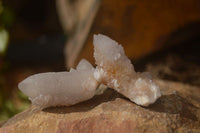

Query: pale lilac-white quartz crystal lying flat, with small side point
18,60,99,107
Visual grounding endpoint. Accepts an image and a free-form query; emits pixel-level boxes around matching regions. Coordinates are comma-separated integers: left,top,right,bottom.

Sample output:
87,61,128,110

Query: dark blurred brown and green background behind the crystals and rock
0,0,200,121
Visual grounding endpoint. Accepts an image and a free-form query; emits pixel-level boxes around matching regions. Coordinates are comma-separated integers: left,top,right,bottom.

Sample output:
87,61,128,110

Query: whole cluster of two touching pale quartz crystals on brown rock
18,34,161,107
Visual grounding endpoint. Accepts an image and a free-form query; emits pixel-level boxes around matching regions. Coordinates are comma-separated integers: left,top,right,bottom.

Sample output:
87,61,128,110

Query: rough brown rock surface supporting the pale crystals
0,80,200,133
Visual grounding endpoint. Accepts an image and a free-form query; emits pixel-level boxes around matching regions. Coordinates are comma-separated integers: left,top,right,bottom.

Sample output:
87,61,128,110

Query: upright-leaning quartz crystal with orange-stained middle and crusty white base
93,34,161,106
